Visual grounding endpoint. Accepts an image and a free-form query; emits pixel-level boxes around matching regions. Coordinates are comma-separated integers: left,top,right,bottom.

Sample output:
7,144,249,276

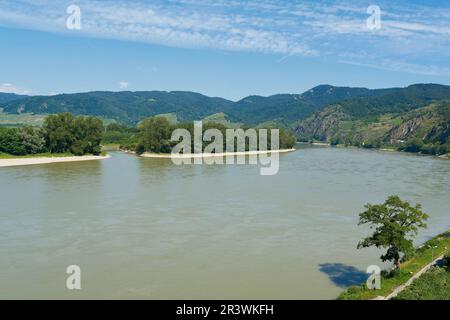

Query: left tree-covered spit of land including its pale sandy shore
0,113,109,167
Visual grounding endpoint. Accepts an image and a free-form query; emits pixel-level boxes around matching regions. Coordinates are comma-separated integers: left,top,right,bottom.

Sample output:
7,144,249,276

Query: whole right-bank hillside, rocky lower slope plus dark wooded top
294,85,450,154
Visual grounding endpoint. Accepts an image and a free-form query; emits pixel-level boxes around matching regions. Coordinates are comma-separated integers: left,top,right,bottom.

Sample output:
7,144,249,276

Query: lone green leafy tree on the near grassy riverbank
358,196,428,268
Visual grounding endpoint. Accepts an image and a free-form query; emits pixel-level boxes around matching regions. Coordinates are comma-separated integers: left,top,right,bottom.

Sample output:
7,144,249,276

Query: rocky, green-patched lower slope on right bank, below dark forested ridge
294,102,450,150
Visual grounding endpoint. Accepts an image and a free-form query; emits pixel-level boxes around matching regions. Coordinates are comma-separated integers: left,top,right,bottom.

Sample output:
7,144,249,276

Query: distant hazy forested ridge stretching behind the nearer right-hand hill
0,85,428,126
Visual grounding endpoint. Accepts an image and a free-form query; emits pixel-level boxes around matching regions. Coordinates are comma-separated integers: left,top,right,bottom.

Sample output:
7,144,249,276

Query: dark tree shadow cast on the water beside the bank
319,263,369,288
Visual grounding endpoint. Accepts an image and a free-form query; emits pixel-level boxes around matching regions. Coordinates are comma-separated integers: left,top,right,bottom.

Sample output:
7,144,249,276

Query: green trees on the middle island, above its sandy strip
110,117,296,154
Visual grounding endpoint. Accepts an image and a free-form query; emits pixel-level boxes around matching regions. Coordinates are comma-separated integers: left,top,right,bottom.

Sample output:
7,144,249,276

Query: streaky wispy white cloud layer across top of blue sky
0,0,450,74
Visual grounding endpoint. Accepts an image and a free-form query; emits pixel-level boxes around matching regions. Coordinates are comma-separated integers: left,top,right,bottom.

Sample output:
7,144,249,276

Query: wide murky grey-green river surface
0,148,450,299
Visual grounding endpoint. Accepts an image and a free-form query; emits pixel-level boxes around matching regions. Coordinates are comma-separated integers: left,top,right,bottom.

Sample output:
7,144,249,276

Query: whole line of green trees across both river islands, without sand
0,113,296,156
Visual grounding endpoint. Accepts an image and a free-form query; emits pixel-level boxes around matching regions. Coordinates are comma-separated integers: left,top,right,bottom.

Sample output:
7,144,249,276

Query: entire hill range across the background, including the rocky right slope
0,84,450,154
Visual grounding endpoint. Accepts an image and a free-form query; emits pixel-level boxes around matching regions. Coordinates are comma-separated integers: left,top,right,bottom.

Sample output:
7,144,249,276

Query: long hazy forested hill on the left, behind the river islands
4,91,233,124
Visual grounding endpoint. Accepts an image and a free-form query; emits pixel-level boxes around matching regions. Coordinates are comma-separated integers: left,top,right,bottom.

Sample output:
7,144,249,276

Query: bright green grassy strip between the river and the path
338,230,450,300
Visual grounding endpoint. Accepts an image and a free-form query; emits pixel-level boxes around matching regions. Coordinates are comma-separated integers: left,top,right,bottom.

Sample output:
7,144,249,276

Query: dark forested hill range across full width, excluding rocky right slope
0,84,450,126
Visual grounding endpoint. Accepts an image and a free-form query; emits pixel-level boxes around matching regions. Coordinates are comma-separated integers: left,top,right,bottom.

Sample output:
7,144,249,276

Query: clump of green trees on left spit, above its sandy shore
0,113,104,156
